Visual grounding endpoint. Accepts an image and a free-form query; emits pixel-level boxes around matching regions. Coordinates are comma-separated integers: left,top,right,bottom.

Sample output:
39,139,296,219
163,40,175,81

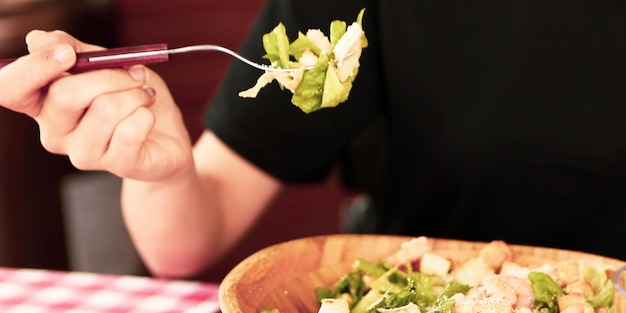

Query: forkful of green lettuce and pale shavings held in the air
239,9,368,113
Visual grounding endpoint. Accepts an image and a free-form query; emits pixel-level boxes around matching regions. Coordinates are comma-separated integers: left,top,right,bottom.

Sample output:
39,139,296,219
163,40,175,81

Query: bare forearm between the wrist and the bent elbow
122,167,223,277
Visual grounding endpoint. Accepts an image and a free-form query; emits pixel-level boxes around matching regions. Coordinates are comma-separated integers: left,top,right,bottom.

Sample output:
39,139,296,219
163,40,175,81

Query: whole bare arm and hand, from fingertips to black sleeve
0,31,279,277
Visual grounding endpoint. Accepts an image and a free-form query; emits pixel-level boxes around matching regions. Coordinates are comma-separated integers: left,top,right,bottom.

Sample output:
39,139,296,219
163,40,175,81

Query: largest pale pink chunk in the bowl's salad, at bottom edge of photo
453,275,535,313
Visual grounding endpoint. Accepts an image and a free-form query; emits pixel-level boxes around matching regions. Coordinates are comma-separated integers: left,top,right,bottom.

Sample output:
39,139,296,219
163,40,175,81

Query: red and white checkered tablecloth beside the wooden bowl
0,268,219,313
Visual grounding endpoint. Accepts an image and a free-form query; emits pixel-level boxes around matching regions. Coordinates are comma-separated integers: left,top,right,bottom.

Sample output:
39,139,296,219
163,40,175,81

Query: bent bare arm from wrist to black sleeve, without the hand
122,131,280,277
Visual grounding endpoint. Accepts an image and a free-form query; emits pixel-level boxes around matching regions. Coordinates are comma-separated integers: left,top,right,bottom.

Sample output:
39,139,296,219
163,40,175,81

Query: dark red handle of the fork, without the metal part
0,43,170,73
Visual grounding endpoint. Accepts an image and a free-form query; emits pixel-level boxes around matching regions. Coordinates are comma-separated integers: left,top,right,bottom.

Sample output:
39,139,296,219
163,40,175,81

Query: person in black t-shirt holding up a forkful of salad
0,0,626,277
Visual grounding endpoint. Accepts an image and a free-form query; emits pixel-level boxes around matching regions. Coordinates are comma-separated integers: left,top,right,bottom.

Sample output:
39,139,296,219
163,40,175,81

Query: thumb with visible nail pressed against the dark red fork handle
0,44,76,116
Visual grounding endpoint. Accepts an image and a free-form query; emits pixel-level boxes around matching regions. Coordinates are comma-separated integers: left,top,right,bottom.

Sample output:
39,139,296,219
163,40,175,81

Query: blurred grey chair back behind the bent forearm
61,172,147,275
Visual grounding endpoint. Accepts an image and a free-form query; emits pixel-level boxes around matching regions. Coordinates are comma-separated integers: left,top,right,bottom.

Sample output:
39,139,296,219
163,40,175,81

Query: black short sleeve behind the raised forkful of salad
204,0,380,182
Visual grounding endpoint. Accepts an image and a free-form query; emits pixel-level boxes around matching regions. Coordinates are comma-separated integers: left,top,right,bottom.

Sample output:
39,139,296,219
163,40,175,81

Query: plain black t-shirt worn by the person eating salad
206,0,626,259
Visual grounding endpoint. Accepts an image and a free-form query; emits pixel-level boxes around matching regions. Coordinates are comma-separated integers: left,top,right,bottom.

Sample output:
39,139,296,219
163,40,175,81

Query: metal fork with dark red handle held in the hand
0,43,295,73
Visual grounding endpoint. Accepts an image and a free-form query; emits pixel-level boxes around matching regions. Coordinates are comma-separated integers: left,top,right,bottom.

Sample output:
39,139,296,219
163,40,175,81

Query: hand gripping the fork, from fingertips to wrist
0,31,193,181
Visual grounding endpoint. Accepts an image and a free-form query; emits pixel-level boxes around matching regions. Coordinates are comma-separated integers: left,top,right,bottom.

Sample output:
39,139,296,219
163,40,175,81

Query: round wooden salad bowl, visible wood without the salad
219,234,626,313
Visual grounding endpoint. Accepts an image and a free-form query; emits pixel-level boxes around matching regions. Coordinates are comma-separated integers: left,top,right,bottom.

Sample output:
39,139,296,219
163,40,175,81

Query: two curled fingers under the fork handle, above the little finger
35,66,154,156
